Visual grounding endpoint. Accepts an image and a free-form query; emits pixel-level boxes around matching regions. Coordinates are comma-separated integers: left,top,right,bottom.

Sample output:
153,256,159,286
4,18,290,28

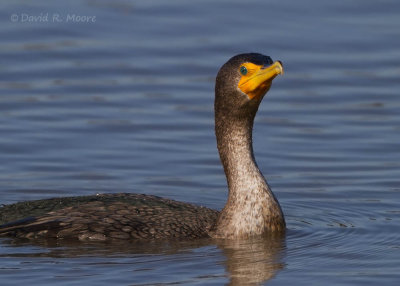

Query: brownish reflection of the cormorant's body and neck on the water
0,234,285,285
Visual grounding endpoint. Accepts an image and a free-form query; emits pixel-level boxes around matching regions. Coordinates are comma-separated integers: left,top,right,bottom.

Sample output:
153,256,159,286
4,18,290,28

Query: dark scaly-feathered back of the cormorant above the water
0,194,218,241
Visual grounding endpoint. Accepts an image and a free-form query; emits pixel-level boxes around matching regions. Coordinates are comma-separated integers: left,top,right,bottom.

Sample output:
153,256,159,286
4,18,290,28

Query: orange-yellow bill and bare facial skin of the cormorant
238,61,283,100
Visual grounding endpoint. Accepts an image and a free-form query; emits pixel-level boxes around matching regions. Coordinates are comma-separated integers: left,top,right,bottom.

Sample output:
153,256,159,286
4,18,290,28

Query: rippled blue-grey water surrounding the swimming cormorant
0,0,400,285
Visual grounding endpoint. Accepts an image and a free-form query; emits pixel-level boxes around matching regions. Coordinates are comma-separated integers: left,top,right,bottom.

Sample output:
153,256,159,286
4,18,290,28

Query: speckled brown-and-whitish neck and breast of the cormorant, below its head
214,113,285,238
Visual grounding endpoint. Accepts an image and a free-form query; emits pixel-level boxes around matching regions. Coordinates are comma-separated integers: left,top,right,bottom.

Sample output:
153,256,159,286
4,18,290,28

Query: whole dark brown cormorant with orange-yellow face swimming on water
0,53,286,241
